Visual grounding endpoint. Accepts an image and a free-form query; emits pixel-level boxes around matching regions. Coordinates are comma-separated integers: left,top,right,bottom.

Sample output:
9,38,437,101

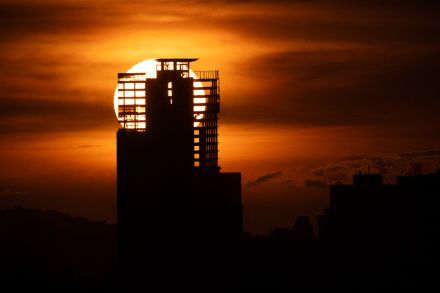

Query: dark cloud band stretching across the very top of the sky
0,0,439,43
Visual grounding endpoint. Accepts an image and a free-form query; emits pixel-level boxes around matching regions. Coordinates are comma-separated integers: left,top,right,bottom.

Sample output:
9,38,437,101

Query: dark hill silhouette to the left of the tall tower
0,207,116,292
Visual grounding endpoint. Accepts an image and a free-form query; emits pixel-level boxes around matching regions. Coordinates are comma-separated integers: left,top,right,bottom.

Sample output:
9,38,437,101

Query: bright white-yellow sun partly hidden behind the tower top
113,59,206,127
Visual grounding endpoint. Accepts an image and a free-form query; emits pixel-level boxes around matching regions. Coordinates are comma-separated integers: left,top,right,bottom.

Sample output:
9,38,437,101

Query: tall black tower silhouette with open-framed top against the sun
117,59,243,288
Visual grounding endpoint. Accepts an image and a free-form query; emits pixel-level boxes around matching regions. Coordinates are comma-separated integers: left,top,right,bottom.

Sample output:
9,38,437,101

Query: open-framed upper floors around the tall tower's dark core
118,59,220,171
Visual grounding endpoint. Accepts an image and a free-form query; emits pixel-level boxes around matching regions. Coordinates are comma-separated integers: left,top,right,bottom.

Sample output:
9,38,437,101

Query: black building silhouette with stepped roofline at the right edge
318,171,440,291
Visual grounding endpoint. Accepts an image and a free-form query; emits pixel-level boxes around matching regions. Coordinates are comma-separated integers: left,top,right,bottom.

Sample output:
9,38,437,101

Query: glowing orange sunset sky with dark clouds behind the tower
0,0,440,233
